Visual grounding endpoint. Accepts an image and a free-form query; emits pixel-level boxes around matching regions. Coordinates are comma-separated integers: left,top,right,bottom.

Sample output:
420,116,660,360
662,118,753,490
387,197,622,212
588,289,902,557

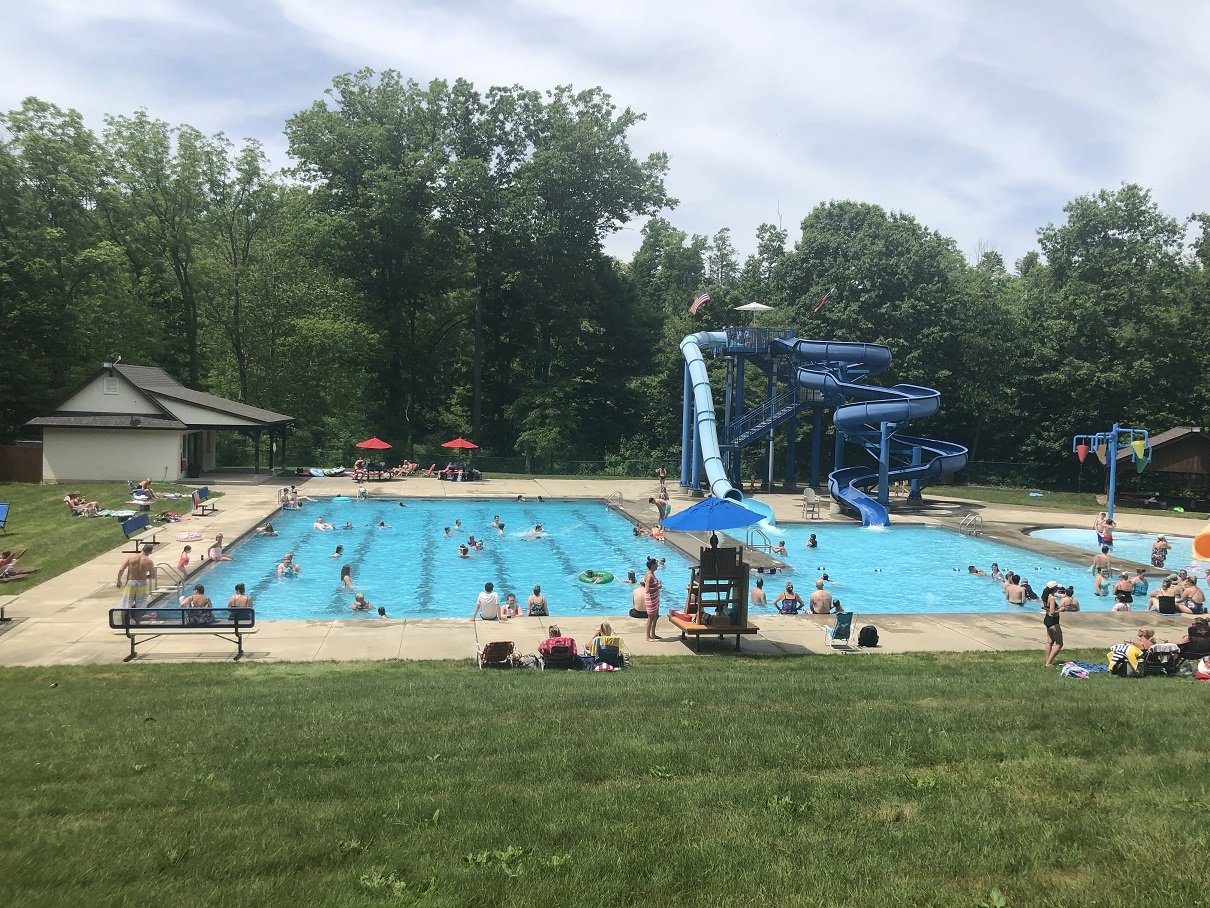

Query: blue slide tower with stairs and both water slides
680,327,967,527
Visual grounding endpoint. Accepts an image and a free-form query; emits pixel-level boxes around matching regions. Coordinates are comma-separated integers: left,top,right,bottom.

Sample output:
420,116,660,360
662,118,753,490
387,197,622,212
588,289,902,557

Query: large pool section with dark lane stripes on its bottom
194,498,691,620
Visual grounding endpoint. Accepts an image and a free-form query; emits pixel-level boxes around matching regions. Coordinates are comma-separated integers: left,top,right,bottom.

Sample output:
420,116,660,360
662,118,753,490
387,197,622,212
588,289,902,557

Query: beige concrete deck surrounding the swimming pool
0,477,1204,666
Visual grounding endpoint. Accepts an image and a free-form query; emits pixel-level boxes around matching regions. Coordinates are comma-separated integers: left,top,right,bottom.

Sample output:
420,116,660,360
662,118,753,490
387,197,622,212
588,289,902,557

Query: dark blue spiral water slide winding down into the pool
773,339,967,527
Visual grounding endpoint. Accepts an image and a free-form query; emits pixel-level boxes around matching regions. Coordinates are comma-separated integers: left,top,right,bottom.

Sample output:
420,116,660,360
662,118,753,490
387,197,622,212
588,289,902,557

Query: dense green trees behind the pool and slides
0,69,1210,484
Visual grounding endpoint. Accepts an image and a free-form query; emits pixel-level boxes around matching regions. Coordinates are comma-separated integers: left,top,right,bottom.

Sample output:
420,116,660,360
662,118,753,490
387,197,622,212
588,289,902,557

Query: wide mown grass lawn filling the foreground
0,653,1210,908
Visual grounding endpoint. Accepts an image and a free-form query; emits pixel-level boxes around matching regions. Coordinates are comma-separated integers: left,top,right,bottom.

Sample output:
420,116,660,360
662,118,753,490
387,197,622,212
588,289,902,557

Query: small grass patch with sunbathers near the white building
0,482,219,596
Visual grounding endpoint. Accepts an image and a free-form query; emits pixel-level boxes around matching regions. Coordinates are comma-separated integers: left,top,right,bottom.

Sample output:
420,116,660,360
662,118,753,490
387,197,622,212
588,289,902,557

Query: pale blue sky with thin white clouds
0,0,1210,263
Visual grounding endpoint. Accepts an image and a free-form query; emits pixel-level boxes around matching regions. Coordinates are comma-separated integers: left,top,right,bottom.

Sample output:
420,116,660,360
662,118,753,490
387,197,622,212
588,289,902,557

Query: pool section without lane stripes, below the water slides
751,523,1108,616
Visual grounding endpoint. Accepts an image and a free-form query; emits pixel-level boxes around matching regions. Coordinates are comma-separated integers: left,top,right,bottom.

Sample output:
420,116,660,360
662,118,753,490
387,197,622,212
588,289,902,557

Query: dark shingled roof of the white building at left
25,363,294,430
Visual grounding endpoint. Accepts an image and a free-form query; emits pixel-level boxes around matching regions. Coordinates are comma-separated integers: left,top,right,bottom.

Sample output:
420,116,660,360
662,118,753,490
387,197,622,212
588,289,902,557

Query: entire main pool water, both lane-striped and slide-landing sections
197,499,1122,620
